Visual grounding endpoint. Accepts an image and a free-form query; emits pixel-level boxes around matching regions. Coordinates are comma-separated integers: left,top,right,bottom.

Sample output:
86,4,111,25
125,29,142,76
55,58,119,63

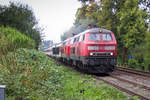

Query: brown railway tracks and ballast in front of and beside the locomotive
93,67,150,100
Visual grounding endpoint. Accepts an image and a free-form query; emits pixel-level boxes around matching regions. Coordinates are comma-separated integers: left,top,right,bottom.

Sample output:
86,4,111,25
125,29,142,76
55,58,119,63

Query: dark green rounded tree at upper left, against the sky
0,2,41,47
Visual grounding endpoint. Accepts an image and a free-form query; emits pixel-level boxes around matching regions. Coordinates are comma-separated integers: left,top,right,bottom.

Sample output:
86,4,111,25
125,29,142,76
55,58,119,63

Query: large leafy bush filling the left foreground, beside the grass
0,49,62,100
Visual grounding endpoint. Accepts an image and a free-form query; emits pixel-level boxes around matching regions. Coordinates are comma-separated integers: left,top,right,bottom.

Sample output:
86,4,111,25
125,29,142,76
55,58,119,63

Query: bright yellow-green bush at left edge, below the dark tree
0,27,35,55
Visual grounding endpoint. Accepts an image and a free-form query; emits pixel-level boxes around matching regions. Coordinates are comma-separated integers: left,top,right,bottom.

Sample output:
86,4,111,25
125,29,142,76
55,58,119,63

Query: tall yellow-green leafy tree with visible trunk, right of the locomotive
117,0,147,62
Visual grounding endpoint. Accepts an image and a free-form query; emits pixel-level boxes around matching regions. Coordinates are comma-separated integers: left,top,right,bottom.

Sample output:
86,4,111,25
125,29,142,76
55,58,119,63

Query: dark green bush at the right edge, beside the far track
128,32,150,71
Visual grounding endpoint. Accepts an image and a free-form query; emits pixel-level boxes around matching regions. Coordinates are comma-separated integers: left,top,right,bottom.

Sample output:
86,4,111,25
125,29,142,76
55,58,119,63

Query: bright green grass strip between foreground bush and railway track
53,66,137,100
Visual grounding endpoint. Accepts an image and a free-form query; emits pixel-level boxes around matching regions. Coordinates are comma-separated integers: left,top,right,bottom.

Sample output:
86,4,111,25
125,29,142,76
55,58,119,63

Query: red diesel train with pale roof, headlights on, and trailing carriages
50,28,117,73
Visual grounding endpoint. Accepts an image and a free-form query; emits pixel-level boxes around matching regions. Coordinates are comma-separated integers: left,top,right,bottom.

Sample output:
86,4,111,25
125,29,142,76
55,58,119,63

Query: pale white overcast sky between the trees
0,0,81,42
